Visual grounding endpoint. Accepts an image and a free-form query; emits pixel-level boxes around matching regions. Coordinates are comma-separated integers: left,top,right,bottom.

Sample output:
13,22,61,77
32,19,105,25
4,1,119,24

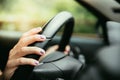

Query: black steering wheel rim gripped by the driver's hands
10,11,77,80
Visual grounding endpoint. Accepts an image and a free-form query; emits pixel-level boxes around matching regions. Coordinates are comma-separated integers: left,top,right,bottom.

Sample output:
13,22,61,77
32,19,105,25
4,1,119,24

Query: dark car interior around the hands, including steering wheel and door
0,0,120,80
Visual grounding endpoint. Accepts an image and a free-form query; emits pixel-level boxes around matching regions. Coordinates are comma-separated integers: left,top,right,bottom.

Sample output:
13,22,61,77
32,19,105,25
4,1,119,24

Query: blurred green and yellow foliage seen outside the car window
0,0,96,33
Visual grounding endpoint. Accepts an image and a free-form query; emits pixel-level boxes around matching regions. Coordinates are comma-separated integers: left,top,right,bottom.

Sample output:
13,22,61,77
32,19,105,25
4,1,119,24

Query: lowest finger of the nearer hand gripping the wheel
9,57,39,68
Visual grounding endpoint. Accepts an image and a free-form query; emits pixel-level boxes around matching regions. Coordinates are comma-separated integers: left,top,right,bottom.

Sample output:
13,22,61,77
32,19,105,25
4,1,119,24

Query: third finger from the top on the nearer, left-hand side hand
14,47,45,58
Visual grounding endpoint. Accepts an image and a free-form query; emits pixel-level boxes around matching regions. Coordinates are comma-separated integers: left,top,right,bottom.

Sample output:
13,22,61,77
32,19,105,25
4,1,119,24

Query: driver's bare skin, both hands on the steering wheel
0,27,70,80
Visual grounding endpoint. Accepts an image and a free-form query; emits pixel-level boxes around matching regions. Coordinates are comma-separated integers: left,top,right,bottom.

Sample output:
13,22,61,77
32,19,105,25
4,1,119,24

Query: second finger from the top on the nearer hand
18,34,46,46
